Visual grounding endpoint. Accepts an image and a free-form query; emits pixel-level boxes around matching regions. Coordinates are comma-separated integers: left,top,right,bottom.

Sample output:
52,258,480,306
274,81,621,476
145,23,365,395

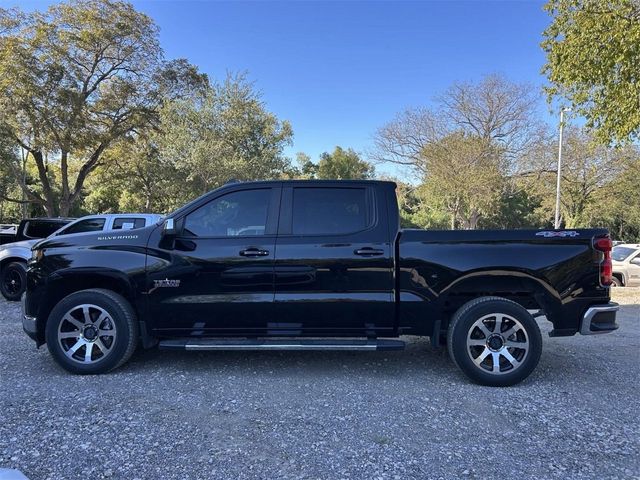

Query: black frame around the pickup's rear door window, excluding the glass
278,185,380,238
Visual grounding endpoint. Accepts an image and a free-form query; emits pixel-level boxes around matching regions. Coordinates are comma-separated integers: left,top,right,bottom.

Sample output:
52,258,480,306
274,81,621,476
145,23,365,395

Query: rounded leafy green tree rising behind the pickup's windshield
158,75,293,200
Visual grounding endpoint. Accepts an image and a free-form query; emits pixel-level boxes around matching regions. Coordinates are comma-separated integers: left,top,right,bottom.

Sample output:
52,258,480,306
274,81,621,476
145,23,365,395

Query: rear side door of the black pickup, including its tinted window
270,183,394,336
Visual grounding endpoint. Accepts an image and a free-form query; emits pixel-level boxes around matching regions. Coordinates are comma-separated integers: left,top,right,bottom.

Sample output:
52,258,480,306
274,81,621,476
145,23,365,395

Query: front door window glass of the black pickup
184,188,271,237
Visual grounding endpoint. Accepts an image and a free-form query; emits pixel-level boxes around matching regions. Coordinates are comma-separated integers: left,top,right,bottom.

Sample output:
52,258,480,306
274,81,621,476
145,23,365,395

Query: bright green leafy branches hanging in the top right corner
542,0,640,143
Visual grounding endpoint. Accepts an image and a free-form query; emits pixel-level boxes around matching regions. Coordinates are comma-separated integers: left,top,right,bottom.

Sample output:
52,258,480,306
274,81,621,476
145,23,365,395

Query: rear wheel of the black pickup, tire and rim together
447,297,542,387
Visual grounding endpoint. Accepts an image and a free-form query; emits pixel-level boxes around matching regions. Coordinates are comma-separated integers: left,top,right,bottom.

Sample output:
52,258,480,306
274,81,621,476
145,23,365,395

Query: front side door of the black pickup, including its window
148,187,280,336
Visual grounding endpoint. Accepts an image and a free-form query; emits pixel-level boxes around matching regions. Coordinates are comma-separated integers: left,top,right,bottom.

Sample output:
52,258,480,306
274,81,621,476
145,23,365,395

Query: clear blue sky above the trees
7,0,549,171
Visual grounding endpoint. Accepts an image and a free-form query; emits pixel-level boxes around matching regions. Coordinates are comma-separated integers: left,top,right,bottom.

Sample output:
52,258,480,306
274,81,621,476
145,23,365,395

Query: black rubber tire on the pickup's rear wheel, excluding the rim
451,299,542,386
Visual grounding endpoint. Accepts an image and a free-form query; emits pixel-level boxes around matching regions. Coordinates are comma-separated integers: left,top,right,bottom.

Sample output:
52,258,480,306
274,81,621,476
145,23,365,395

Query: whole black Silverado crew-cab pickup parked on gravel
23,181,618,386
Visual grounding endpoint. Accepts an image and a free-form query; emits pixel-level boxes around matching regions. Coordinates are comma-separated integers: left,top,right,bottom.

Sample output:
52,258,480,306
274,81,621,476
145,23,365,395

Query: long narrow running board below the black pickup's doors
158,338,405,351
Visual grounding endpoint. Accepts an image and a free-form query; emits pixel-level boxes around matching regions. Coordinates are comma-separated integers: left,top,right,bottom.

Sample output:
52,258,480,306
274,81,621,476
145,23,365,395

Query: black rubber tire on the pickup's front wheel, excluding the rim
45,291,134,374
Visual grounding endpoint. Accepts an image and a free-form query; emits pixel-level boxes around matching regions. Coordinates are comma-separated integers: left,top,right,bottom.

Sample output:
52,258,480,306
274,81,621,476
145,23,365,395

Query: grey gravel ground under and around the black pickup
0,289,640,480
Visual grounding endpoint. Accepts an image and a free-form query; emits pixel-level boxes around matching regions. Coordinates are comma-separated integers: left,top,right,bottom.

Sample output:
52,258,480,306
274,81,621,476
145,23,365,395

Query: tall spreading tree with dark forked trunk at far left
0,0,202,215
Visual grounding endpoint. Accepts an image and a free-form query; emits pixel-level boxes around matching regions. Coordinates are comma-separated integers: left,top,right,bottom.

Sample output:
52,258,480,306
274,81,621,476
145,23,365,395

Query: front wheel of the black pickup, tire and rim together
45,289,139,374
